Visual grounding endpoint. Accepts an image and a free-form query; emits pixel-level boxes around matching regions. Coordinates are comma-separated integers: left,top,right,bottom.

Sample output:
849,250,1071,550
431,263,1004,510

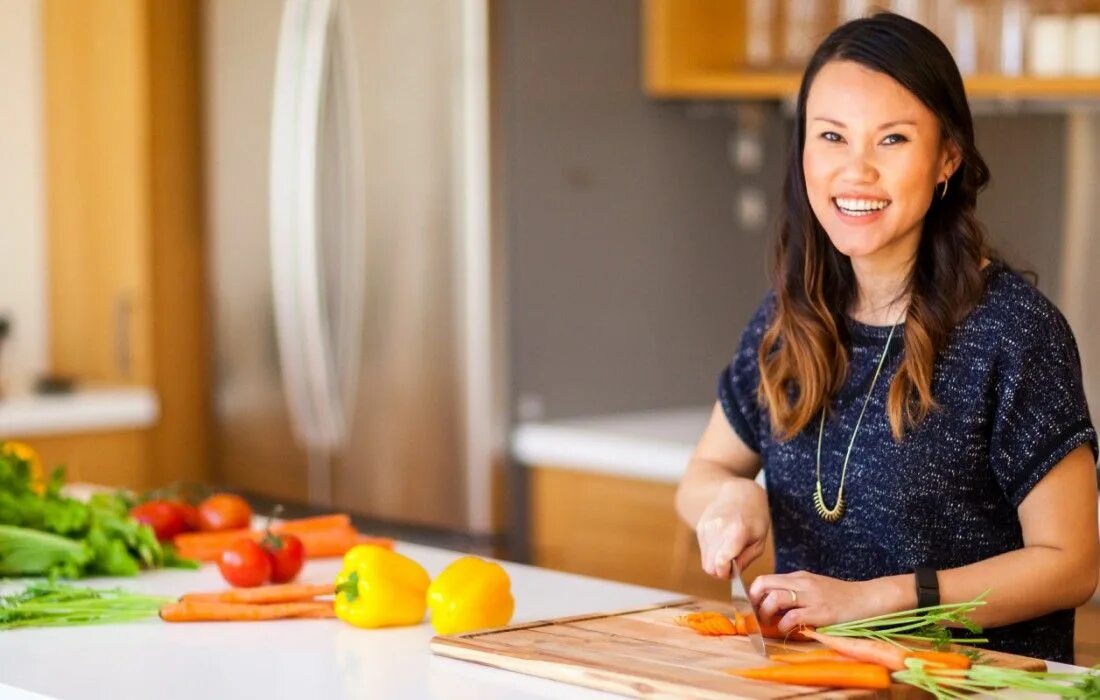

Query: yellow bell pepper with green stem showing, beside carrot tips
333,545,431,627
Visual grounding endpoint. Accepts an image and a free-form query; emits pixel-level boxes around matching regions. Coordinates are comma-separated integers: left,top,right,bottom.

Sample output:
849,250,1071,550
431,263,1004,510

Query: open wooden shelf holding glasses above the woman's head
641,0,1100,100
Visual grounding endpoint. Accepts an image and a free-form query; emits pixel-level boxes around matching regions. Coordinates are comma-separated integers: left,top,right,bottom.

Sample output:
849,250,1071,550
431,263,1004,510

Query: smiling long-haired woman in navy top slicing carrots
677,13,1100,661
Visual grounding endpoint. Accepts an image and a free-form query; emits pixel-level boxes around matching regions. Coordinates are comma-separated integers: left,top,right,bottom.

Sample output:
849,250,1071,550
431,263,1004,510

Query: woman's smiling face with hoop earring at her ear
802,61,956,263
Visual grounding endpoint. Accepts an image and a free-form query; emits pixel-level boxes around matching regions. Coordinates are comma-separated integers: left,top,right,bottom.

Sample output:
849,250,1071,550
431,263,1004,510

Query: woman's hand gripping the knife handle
695,478,771,579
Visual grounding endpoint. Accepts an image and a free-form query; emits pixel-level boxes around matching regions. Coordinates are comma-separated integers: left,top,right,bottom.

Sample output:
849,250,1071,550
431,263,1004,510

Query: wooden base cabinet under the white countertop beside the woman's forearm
528,466,774,600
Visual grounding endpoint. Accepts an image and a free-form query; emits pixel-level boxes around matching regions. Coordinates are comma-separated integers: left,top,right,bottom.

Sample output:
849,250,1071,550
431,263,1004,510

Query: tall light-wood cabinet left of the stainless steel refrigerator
35,0,210,485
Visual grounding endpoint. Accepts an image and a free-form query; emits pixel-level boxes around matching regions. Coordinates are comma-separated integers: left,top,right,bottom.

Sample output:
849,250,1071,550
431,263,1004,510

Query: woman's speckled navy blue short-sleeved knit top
718,262,1098,663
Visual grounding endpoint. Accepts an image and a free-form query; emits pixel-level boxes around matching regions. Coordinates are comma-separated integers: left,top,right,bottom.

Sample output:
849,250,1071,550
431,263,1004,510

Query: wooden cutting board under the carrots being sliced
431,599,1046,700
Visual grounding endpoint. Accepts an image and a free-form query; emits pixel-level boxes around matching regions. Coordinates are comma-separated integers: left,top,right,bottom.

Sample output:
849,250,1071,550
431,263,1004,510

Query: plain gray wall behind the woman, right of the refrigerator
497,0,1065,418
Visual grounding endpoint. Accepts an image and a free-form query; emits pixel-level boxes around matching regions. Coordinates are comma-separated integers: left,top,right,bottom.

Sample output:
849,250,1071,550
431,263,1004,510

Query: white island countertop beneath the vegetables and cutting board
0,543,1073,700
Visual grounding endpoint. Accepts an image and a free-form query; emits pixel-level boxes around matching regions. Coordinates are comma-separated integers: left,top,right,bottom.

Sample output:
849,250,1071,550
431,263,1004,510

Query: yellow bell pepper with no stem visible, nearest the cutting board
428,557,516,634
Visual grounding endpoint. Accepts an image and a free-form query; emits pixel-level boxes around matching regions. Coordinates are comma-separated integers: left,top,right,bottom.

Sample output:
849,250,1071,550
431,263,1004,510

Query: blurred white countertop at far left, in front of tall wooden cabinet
0,386,161,438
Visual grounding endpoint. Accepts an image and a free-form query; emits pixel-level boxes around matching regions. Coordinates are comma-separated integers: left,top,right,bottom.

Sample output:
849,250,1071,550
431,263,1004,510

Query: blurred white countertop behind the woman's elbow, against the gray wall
512,406,713,483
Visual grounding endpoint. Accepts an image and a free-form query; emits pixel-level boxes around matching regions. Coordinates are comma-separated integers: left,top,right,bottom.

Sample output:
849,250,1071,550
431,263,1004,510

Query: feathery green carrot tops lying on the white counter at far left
0,582,172,630
